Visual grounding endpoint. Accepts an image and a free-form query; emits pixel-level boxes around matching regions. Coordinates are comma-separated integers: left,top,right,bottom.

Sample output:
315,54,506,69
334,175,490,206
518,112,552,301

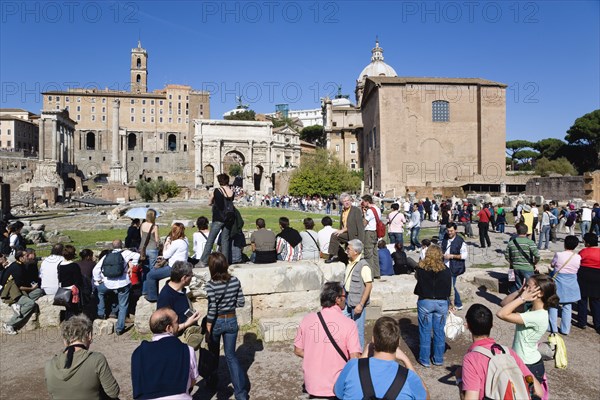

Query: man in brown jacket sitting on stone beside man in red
325,193,365,263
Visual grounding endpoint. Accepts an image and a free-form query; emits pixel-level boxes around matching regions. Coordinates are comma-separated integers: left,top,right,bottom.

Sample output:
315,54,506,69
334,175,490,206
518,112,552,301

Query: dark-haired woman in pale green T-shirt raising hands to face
496,274,560,387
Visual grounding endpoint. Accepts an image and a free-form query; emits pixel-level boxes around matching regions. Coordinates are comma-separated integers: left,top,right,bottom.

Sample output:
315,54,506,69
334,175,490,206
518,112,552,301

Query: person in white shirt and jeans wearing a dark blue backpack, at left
92,239,140,335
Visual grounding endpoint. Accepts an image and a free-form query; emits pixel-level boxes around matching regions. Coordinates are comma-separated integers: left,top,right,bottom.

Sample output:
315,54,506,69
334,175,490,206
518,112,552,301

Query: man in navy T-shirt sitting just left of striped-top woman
156,261,202,350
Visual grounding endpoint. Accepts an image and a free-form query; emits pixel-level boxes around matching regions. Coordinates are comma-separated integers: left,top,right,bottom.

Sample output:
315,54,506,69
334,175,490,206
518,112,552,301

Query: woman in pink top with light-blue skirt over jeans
548,235,581,335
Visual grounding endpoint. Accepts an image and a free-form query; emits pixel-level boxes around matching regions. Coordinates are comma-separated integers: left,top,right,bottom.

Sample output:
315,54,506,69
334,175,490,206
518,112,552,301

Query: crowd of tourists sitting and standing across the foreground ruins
0,174,600,399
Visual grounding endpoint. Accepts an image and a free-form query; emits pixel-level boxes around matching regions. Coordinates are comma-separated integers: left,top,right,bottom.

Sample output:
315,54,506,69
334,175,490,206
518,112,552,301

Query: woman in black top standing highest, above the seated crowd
200,174,234,266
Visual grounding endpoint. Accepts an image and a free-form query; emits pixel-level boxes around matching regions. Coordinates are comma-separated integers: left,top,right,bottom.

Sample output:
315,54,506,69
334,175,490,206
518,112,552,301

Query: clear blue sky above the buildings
0,0,600,140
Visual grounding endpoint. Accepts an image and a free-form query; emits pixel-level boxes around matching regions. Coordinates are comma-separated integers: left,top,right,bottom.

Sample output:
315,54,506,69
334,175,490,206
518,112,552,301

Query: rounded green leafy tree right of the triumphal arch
289,149,361,196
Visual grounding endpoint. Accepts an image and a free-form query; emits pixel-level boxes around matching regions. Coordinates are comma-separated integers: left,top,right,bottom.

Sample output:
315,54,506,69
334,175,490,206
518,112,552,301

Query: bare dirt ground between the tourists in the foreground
0,292,600,400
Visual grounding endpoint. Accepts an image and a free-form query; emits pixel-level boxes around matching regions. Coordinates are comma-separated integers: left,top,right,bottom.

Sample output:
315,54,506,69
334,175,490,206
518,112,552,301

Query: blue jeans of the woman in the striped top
209,317,248,400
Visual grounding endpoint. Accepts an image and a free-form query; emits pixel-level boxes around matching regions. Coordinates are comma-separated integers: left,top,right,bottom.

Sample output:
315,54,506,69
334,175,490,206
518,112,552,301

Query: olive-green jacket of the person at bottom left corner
45,349,119,400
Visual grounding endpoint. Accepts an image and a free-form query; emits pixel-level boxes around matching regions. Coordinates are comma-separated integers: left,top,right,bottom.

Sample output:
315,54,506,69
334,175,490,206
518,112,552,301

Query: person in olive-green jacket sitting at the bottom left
45,315,119,400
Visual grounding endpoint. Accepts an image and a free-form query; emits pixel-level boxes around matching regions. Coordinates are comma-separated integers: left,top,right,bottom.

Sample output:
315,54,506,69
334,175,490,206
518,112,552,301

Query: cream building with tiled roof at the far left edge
0,108,39,155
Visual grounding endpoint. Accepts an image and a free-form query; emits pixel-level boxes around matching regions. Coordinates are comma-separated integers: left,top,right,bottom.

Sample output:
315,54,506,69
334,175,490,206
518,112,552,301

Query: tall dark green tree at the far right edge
564,110,600,172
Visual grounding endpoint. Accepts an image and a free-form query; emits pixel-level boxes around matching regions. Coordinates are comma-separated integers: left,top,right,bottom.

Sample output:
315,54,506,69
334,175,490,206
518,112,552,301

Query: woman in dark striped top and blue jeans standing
206,253,248,400
